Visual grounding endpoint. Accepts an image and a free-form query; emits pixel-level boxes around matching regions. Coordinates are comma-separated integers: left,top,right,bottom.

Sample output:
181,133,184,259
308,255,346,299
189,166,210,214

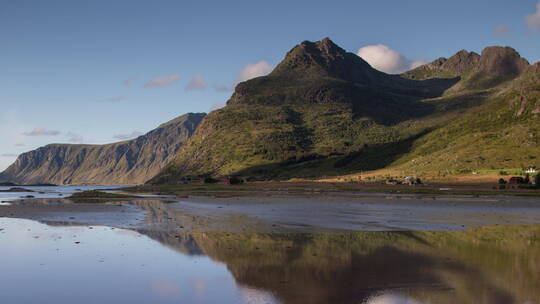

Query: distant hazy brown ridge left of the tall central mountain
0,113,206,185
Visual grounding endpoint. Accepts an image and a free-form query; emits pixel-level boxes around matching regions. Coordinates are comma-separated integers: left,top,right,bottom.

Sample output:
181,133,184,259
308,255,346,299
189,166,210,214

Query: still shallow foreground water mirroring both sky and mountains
0,218,540,304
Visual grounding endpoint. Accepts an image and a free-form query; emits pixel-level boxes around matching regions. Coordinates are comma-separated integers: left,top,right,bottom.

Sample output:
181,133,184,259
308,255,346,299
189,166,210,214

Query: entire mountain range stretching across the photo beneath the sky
0,38,540,184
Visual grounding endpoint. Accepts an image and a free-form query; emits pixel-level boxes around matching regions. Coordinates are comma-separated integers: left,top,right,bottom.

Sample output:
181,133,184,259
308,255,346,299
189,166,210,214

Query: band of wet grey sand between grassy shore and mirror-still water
0,194,540,233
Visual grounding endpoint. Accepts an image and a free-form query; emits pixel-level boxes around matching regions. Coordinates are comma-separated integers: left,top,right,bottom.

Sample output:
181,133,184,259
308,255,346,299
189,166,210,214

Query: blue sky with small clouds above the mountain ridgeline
0,0,540,170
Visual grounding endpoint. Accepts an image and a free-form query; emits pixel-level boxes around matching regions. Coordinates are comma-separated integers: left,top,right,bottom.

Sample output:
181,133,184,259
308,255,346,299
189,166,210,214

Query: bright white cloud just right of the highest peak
357,44,426,74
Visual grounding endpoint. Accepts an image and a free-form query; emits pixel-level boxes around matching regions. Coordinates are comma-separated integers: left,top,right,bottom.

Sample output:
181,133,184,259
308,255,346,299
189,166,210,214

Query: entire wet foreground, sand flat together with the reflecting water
0,186,540,304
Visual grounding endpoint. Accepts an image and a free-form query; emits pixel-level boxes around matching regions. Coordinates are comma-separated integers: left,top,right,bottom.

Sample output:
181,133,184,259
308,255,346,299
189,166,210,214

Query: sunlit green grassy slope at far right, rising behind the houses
393,63,540,174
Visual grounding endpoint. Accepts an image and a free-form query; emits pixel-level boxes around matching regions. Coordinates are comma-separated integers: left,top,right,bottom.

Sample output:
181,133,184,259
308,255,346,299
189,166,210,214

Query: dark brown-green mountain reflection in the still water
138,226,540,303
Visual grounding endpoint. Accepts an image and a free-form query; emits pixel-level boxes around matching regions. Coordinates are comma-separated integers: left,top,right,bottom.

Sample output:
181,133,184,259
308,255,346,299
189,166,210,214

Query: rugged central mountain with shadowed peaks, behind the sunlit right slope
150,38,531,183
